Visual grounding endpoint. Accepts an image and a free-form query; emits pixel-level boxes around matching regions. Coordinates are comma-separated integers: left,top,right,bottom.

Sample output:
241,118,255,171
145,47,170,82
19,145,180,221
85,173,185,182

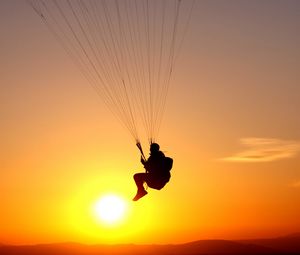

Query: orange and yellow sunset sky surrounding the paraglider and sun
0,0,300,244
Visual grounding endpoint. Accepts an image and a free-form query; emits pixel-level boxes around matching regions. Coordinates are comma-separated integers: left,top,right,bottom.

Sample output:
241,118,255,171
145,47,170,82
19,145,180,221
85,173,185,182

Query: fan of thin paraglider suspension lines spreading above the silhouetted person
28,0,194,143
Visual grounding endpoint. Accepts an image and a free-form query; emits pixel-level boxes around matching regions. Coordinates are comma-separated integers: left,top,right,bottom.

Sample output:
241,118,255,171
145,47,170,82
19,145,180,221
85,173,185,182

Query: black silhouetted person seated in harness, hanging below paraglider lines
133,143,173,201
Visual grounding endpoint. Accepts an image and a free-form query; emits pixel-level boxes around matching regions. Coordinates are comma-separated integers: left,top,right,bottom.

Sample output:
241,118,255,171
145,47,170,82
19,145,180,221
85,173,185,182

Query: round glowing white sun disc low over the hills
94,195,127,225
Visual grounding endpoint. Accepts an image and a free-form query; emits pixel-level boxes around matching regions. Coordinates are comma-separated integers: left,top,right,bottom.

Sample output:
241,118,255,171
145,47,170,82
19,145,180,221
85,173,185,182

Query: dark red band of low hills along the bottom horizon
0,234,300,255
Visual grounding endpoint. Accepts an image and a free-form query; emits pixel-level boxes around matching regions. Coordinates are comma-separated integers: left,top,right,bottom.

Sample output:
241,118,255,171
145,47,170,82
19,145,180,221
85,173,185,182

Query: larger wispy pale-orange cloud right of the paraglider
222,137,300,162
